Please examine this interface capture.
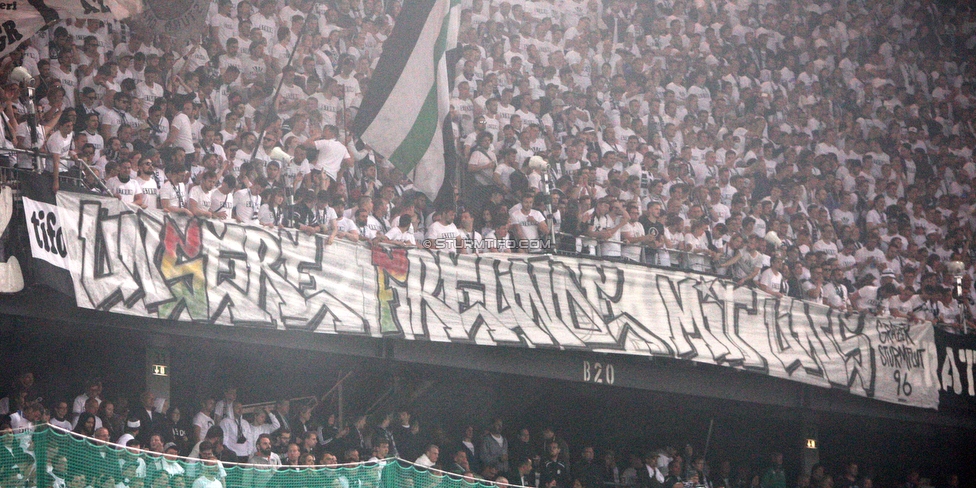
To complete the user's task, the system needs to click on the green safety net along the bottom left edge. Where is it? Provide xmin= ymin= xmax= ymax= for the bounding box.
xmin=0 ymin=426 xmax=504 ymax=488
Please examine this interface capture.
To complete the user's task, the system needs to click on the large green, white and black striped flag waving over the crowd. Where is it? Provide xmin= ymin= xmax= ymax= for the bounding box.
xmin=353 ymin=0 xmax=460 ymax=200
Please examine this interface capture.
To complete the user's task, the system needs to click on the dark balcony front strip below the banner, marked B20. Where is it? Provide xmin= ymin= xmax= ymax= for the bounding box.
xmin=0 ymin=288 xmax=976 ymax=430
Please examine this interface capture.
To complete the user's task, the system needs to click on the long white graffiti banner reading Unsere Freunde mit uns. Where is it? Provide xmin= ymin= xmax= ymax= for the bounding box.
xmin=58 ymin=192 xmax=938 ymax=408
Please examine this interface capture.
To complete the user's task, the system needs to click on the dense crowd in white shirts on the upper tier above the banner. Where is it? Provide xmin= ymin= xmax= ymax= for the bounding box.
xmin=0 ymin=0 xmax=976 ymax=344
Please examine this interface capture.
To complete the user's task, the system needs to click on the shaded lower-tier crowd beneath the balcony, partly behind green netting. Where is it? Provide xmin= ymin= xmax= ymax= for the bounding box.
xmin=0 ymin=372 xmax=960 ymax=488
